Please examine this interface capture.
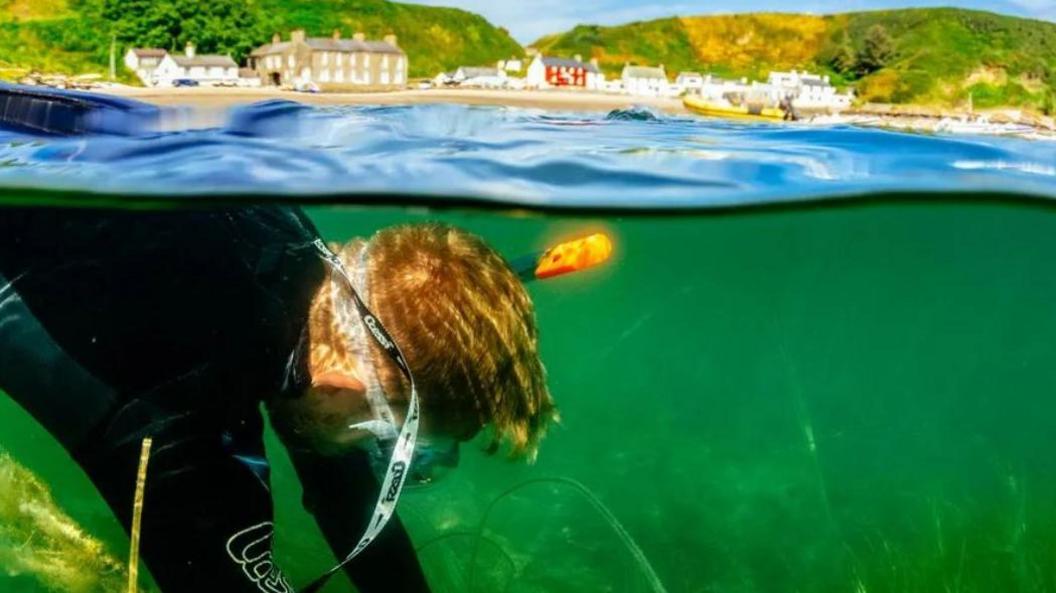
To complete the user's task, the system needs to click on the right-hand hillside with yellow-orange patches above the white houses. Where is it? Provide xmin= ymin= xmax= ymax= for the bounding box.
xmin=532 ymin=8 xmax=1056 ymax=112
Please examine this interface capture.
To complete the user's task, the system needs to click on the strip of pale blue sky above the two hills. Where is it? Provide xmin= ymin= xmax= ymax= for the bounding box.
xmin=401 ymin=0 xmax=1056 ymax=44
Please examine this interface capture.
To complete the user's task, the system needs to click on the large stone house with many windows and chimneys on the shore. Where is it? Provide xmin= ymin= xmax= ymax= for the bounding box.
xmin=249 ymin=30 xmax=408 ymax=89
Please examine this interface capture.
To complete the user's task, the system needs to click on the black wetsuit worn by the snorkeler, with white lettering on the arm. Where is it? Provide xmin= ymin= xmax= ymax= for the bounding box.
xmin=0 ymin=207 xmax=428 ymax=593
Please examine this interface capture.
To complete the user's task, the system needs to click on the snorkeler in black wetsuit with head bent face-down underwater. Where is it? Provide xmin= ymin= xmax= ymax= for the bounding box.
xmin=0 ymin=207 xmax=555 ymax=593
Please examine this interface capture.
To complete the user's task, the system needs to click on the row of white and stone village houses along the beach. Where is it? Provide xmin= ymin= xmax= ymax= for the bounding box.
xmin=113 ymin=30 xmax=854 ymax=113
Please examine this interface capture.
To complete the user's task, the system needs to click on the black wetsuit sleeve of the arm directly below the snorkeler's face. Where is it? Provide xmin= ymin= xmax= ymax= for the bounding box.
xmin=289 ymin=447 xmax=429 ymax=593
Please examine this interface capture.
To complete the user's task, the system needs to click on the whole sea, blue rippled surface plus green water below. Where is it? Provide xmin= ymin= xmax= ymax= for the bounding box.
xmin=0 ymin=103 xmax=1056 ymax=593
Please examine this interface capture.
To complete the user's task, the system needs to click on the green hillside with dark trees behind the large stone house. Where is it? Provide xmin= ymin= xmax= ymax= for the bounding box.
xmin=0 ymin=0 xmax=524 ymax=79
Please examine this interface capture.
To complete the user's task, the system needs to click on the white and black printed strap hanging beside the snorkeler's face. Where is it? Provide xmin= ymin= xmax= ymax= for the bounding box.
xmin=303 ymin=238 xmax=418 ymax=593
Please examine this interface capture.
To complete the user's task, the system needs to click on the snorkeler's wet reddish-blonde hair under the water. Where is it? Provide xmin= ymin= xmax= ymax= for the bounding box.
xmin=312 ymin=224 xmax=557 ymax=458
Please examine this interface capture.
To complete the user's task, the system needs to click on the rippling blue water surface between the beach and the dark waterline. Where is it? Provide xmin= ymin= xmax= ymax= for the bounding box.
xmin=0 ymin=103 xmax=1056 ymax=208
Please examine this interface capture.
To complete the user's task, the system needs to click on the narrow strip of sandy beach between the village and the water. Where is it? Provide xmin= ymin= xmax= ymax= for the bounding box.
xmin=99 ymin=87 xmax=687 ymax=114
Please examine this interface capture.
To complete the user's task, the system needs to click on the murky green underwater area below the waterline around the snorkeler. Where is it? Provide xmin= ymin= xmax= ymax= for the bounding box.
xmin=0 ymin=199 xmax=1056 ymax=593
